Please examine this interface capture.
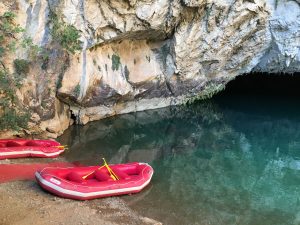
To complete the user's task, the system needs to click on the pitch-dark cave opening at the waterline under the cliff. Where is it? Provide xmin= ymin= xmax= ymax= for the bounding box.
xmin=212 ymin=73 xmax=300 ymax=117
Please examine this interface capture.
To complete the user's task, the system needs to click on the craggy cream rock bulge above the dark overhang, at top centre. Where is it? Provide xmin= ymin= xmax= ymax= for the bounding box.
xmin=61 ymin=0 xmax=181 ymax=47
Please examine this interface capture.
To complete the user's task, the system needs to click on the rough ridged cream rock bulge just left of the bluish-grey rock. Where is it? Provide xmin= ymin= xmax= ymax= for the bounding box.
xmin=174 ymin=1 xmax=269 ymax=80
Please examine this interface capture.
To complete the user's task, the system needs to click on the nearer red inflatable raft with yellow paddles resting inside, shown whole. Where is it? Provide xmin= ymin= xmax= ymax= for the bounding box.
xmin=35 ymin=163 xmax=153 ymax=200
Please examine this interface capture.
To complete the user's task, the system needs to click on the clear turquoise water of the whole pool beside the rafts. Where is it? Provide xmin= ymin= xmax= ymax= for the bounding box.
xmin=60 ymin=93 xmax=300 ymax=225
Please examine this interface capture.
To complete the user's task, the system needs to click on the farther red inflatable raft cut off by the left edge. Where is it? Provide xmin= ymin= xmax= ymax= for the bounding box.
xmin=0 ymin=139 xmax=65 ymax=159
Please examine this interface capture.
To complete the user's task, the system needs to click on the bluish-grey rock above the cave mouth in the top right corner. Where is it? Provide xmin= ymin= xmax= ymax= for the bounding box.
xmin=254 ymin=1 xmax=300 ymax=73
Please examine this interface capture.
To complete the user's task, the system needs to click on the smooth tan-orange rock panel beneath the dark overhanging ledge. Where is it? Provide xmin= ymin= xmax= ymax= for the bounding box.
xmin=59 ymin=40 xmax=163 ymax=107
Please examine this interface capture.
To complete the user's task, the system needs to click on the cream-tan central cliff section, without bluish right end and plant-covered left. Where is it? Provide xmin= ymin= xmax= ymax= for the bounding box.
xmin=52 ymin=0 xmax=271 ymax=123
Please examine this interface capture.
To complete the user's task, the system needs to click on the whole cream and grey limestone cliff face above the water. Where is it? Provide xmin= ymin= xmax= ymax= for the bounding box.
xmin=0 ymin=0 xmax=300 ymax=136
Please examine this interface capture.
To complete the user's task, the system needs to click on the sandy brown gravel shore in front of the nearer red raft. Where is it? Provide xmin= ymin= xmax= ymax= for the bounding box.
xmin=0 ymin=176 xmax=161 ymax=225
